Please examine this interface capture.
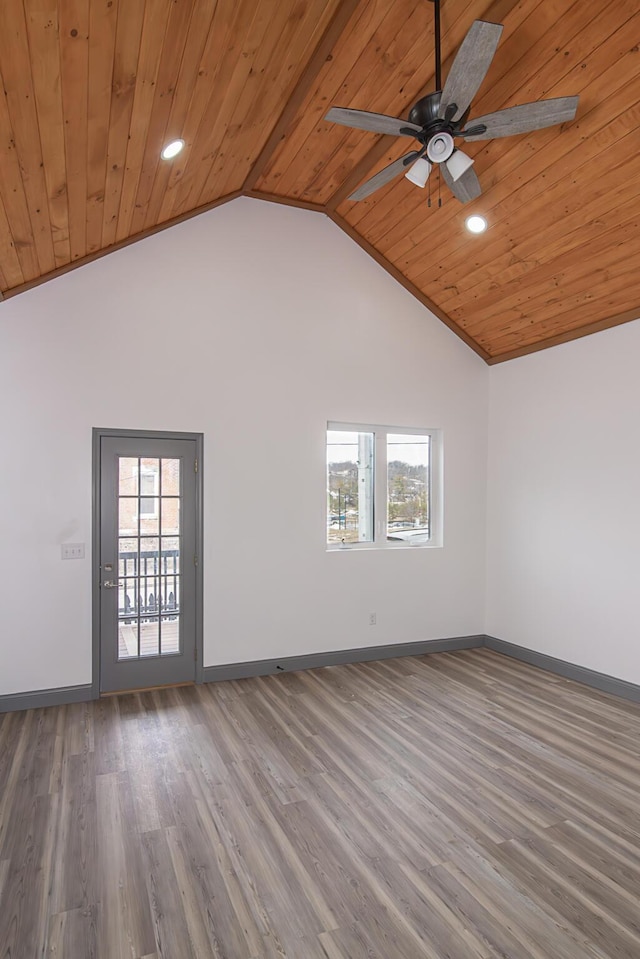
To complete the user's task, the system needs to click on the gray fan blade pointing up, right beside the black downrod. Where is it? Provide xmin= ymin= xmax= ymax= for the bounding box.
xmin=438 ymin=20 xmax=503 ymax=121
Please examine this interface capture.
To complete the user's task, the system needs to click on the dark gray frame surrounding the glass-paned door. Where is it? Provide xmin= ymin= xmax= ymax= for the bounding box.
xmin=91 ymin=426 xmax=204 ymax=699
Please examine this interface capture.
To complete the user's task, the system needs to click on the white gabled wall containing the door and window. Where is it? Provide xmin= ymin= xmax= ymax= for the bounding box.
xmin=0 ymin=199 xmax=489 ymax=694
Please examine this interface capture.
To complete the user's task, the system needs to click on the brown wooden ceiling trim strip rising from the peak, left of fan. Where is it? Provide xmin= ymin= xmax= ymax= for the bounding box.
xmin=242 ymin=0 xmax=360 ymax=194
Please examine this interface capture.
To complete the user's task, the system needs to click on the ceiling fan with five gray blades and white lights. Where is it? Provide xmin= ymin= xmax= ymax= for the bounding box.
xmin=325 ymin=0 xmax=579 ymax=203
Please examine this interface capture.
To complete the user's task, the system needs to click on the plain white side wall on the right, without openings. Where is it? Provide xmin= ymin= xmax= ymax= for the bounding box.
xmin=486 ymin=322 xmax=640 ymax=683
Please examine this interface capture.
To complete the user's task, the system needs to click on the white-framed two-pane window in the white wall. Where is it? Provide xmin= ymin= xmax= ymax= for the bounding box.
xmin=327 ymin=423 xmax=442 ymax=547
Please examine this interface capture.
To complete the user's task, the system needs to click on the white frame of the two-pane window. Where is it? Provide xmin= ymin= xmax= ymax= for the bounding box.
xmin=324 ymin=420 xmax=444 ymax=553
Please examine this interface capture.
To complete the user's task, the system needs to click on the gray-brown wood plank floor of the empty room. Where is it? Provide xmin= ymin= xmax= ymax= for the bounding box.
xmin=0 ymin=649 xmax=640 ymax=959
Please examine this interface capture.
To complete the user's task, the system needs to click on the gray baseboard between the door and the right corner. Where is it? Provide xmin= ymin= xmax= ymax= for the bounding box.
xmin=203 ymin=635 xmax=484 ymax=683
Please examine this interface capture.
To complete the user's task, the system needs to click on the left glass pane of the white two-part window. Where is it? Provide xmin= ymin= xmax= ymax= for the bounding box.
xmin=327 ymin=430 xmax=374 ymax=543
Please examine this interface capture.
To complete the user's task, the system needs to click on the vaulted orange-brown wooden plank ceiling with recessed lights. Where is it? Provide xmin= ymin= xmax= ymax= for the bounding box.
xmin=0 ymin=0 xmax=640 ymax=363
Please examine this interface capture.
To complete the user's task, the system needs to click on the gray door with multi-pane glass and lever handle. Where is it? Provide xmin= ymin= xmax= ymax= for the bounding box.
xmin=99 ymin=434 xmax=197 ymax=692
